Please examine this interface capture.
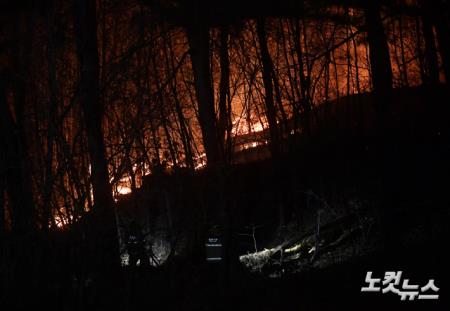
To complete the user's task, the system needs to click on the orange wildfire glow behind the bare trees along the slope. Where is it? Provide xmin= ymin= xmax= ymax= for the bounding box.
xmin=1 ymin=0 xmax=444 ymax=227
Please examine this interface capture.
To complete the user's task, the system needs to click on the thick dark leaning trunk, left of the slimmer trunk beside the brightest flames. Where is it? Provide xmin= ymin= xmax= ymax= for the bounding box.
xmin=187 ymin=16 xmax=222 ymax=165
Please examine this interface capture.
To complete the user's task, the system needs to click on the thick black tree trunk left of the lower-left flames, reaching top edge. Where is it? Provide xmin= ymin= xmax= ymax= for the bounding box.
xmin=73 ymin=0 xmax=119 ymax=271
